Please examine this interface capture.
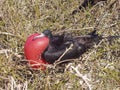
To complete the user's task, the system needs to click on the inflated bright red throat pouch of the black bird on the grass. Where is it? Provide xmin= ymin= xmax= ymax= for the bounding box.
xmin=24 ymin=33 xmax=49 ymax=70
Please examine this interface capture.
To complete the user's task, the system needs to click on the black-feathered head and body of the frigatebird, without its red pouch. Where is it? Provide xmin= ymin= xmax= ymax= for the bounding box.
xmin=36 ymin=30 xmax=102 ymax=64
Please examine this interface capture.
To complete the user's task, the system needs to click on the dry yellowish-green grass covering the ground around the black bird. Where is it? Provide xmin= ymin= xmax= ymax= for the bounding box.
xmin=0 ymin=0 xmax=120 ymax=90
